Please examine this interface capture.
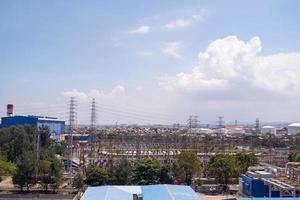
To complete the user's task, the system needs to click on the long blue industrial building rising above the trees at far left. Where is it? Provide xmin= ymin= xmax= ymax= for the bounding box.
xmin=1 ymin=116 xmax=65 ymax=139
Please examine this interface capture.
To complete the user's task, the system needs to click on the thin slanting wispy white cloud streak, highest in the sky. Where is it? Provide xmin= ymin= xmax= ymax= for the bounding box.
xmin=162 ymin=15 xmax=202 ymax=30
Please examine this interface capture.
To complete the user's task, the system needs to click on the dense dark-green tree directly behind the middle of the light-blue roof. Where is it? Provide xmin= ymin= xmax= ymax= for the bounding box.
xmin=131 ymin=159 xmax=160 ymax=185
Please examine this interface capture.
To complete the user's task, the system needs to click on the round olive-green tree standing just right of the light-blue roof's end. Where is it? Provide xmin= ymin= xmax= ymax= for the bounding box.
xmin=206 ymin=154 xmax=240 ymax=186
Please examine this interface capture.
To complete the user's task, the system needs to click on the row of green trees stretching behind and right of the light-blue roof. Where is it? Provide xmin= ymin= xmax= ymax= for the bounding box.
xmin=74 ymin=151 xmax=258 ymax=189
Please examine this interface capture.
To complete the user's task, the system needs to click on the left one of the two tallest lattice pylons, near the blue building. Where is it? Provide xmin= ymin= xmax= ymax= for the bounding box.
xmin=68 ymin=97 xmax=76 ymax=172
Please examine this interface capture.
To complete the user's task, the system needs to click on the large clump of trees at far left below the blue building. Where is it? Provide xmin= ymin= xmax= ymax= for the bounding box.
xmin=0 ymin=126 xmax=65 ymax=191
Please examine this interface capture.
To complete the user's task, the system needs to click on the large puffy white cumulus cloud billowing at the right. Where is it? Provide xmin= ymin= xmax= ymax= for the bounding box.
xmin=159 ymin=36 xmax=300 ymax=97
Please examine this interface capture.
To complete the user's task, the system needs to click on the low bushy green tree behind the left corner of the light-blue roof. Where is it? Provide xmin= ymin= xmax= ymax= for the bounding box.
xmin=85 ymin=165 xmax=108 ymax=186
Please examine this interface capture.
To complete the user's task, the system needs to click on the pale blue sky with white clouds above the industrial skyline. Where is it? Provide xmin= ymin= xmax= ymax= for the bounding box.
xmin=0 ymin=0 xmax=300 ymax=124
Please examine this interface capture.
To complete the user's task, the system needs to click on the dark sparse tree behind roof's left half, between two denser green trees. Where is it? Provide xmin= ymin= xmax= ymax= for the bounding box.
xmin=108 ymin=159 xmax=131 ymax=185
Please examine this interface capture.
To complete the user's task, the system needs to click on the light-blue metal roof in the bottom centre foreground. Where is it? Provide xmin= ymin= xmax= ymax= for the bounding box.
xmin=81 ymin=185 xmax=201 ymax=200
